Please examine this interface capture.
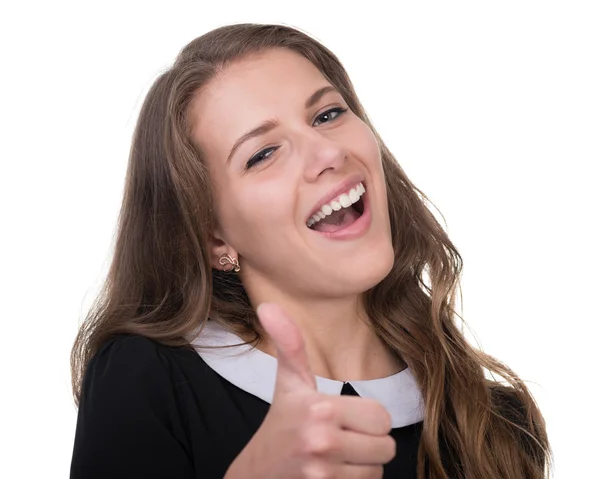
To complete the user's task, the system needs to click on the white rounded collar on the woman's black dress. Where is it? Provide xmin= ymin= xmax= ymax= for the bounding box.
xmin=191 ymin=320 xmax=424 ymax=428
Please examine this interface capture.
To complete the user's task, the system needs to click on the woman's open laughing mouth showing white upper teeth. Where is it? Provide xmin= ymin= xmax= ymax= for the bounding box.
xmin=306 ymin=182 xmax=366 ymax=233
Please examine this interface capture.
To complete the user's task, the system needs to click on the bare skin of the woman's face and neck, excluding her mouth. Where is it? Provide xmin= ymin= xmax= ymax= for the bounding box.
xmin=190 ymin=49 xmax=405 ymax=380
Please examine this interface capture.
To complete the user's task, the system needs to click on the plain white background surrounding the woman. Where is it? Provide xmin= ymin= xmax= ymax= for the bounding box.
xmin=0 ymin=0 xmax=600 ymax=479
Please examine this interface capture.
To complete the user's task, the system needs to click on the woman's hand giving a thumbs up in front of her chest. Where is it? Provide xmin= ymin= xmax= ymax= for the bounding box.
xmin=225 ymin=303 xmax=396 ymax=479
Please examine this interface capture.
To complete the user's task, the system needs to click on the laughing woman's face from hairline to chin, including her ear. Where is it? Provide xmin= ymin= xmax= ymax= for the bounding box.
xmin=190 ymin=49 xmax=394 ymax=301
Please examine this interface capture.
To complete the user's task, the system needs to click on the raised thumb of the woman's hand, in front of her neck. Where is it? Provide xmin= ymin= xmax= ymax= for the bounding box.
xmin=256 ymin=303 xmax=317 ymax=395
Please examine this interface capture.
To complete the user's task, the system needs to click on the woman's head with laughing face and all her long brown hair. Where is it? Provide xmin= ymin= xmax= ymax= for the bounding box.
xmin=72 ymin=24 xmax=547 ymax=478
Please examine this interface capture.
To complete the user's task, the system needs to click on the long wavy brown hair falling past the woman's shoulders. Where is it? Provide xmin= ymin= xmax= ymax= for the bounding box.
xmin=71 ymin=24 xmax=552 ymax=479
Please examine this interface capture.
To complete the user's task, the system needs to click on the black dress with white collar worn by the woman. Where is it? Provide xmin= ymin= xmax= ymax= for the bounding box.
xmin=71 ymin=321 xmax=432 ymax=479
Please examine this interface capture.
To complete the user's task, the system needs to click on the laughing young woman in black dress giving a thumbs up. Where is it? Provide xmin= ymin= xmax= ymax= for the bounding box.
xmin=71 ymin=24 xmax=551 ymax=479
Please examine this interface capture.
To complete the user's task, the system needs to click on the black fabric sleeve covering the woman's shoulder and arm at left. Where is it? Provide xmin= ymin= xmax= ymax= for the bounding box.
xmin=71 ymin=336 xmax=195 ymax=479
